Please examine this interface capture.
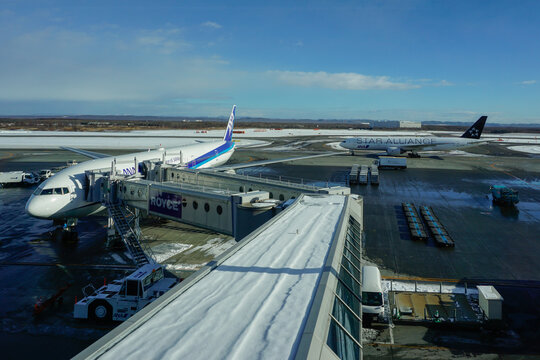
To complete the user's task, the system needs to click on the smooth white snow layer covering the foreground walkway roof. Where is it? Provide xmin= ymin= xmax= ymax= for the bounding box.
xmin=101 ymin=195 xmax=344 ymax=359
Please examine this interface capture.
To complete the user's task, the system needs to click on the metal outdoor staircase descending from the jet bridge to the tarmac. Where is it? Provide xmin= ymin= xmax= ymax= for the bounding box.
xmin=107 ymin=203 xmax=154 ymax=267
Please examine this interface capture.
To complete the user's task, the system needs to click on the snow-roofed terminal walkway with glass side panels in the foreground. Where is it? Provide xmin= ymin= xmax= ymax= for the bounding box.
xmin=76 ymin=193 xmax=363 ymax=359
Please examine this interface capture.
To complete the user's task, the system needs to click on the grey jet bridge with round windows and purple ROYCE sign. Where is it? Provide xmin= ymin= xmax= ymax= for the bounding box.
xmin=105 ymin=164 xmax=350 ymax=240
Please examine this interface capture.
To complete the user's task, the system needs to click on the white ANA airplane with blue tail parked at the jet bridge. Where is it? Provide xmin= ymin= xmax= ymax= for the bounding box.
xmin=26 ymin=105 xmax=236 ymax=220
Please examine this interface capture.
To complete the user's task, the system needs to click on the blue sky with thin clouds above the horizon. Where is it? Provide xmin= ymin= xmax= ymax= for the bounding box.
xmin=0 ymin=0 xmax=540 ymax=124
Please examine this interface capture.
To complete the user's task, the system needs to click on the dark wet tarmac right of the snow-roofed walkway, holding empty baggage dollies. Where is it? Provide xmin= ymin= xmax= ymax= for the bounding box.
xmin=234 ymin=145 xmax=540 ymax=359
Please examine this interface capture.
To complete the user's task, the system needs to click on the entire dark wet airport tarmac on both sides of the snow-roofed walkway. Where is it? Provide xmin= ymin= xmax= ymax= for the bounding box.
xmin=0 ymin=139 xmax=540 ymax=358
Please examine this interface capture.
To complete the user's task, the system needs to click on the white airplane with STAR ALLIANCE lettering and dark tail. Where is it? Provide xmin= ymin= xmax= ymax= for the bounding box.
xmin=340 ymin=116 xmax=487 ymax=155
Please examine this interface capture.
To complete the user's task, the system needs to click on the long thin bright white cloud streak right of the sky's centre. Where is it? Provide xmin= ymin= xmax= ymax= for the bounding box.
xmin=269 ymin=71 xmax=420 ymax=90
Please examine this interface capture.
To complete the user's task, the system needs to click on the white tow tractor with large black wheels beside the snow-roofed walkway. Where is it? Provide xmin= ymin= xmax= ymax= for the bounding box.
xmin=73 ymin=264 xmax=177 ymax=321
